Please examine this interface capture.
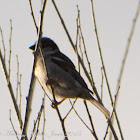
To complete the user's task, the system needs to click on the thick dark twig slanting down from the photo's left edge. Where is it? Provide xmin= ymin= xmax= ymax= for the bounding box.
xmin=0 ymin=27 xmax=23 ymax=129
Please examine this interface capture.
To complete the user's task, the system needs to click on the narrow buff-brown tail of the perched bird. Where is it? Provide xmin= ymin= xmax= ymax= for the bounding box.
xmin=89 ymin=98 xmax=110 ymax=119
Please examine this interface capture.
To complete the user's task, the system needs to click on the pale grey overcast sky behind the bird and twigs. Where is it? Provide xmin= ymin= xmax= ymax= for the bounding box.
xmin=0 ymin=0 xmax=140 ymax=140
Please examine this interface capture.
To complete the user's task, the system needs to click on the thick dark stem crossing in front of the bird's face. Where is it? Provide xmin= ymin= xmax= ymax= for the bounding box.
xmin=21 ymin=0 xmax=47 ymax=140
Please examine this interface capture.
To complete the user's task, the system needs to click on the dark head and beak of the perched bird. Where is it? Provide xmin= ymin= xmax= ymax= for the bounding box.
xmin=29 ymin=37 xmax=59 ymax=52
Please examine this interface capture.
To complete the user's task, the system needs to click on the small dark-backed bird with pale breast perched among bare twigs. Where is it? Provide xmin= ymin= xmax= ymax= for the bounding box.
xmin=29 ymin=37 xmax=110 ymax=119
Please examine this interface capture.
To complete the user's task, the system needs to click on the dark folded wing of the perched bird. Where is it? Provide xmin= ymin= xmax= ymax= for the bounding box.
xmin=51 ymin=51 xmax=88 ymax=89
